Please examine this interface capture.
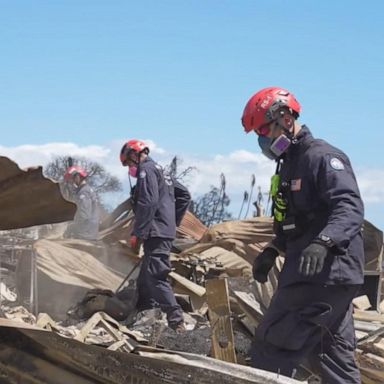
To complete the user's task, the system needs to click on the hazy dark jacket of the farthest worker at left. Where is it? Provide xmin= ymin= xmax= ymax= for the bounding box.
xmin=67 ymin=183 xmax=99 ymax=240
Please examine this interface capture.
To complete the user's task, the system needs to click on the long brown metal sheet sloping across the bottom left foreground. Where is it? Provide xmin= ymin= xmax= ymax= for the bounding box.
xmin=0 ymin=322 xmax=299 ymax=384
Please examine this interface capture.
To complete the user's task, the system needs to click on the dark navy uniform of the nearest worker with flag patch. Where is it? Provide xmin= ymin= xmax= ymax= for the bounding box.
xmin=251 ymin=126 xmax=364 ymax=384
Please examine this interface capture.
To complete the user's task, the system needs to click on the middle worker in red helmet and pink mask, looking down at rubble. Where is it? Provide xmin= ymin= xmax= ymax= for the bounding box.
xmin=120 ymin=139 xmax=190 ymax=332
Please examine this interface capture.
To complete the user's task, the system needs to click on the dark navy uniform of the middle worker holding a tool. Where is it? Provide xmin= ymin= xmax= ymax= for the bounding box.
xmin=132 ymin=157 xmax=184 ymax=327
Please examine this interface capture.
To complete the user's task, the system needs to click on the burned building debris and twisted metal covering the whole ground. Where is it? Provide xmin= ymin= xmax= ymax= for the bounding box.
xmin=0 ymin=158 xmax=384 ymax=384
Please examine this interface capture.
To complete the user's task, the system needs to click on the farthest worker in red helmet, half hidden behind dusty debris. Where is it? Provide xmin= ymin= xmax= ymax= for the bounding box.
xmin=64 ymin=166 xmax=99 ymax=240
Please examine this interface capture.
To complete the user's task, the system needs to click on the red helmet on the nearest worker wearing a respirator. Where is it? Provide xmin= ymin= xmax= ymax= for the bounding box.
xmin=241 ymin=87 xmax=301 ymax=135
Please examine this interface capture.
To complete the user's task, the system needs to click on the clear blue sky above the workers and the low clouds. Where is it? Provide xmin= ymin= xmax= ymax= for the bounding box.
xmin=0 ymin=0 xmax=384 ymax=228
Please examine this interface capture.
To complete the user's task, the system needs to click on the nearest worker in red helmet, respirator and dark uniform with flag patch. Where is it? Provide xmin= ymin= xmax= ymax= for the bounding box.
xmin=242 ymin=87 xmax=364 ymax=384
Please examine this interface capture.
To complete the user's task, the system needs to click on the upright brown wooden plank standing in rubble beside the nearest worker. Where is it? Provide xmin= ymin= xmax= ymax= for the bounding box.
xmin=205 ymin=279 xmax=236 ymax=363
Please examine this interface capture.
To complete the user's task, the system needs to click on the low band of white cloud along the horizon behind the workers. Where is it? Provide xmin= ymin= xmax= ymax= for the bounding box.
xmin=0 ymin=140 xmax=384 ymax=225
